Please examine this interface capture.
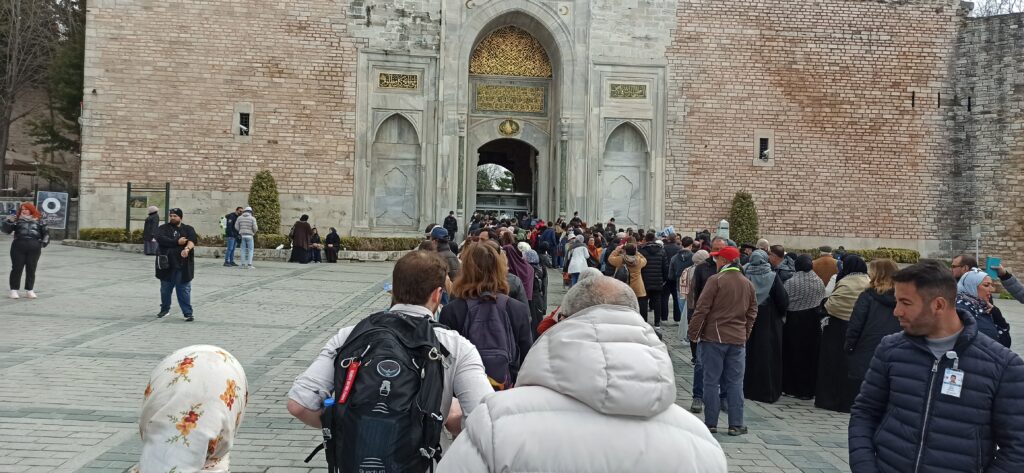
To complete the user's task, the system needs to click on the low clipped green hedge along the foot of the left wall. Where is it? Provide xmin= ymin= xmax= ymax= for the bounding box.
xmin=79 ymin=228 xmax=422 ymax=251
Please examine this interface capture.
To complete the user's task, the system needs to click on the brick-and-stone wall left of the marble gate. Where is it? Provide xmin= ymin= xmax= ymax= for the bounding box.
xmin=82 ymin=0 xmax=357 ymax=233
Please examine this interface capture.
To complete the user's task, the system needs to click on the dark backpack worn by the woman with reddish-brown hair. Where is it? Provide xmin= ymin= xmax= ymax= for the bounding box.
xmin=461 ymin=293 xmax=519 ymax=391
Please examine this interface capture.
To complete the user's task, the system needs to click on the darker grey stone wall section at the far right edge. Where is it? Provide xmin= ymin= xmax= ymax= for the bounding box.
xmin=945 ymin=14 xmax=1024 ymax=271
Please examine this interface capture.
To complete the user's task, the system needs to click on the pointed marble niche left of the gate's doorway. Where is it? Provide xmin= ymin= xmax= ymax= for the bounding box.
xmin=370 ymin=114 xmax=420 ymax=228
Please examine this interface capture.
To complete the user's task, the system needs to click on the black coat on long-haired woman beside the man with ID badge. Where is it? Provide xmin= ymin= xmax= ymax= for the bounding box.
xmin=844 ymin=289 xmax=902 ymax=380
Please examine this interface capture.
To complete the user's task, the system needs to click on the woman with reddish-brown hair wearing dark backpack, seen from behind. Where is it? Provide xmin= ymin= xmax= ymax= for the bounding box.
xmin=439 ymin=244 xmax=534 ymax=391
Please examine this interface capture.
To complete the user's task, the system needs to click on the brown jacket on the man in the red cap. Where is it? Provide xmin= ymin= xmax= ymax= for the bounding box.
xmin=689 ymin=270 xmax=758 ymax=345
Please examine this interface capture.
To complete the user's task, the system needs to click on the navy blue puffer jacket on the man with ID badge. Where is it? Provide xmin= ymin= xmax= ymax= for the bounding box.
xmin=850 ymin=312 xmax=1024 ymax=473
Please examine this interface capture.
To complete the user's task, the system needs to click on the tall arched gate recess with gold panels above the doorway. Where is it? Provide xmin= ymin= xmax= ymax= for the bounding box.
xmin=464 ymin=22 xmax=557 ymax=218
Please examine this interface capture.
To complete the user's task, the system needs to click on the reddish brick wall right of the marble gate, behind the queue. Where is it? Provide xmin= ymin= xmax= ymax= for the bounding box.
xmin=666 ymin=0 xmax=964 ymax=252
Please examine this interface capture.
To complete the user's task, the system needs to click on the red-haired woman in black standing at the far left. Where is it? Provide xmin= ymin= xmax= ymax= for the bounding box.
xmin=0 ymin=202 xmax=50 ymax=299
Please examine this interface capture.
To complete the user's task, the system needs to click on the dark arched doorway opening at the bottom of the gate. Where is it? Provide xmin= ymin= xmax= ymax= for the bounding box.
xmin=476 ymin=138 xmax=539 ymax=217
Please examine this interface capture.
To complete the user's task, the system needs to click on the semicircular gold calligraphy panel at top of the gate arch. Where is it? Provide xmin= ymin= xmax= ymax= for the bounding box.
xmin=469 ymin=27 xmax=551 ymax=78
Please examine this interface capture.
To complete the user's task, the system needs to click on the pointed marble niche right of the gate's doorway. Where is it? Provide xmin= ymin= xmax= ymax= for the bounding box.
xmin=601 ymin=122 xmax=648 ymax=228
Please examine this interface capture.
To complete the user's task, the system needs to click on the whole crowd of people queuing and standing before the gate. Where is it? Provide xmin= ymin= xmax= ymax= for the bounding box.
xmin=9 ymin=204 xmax=1024 ymax=473
